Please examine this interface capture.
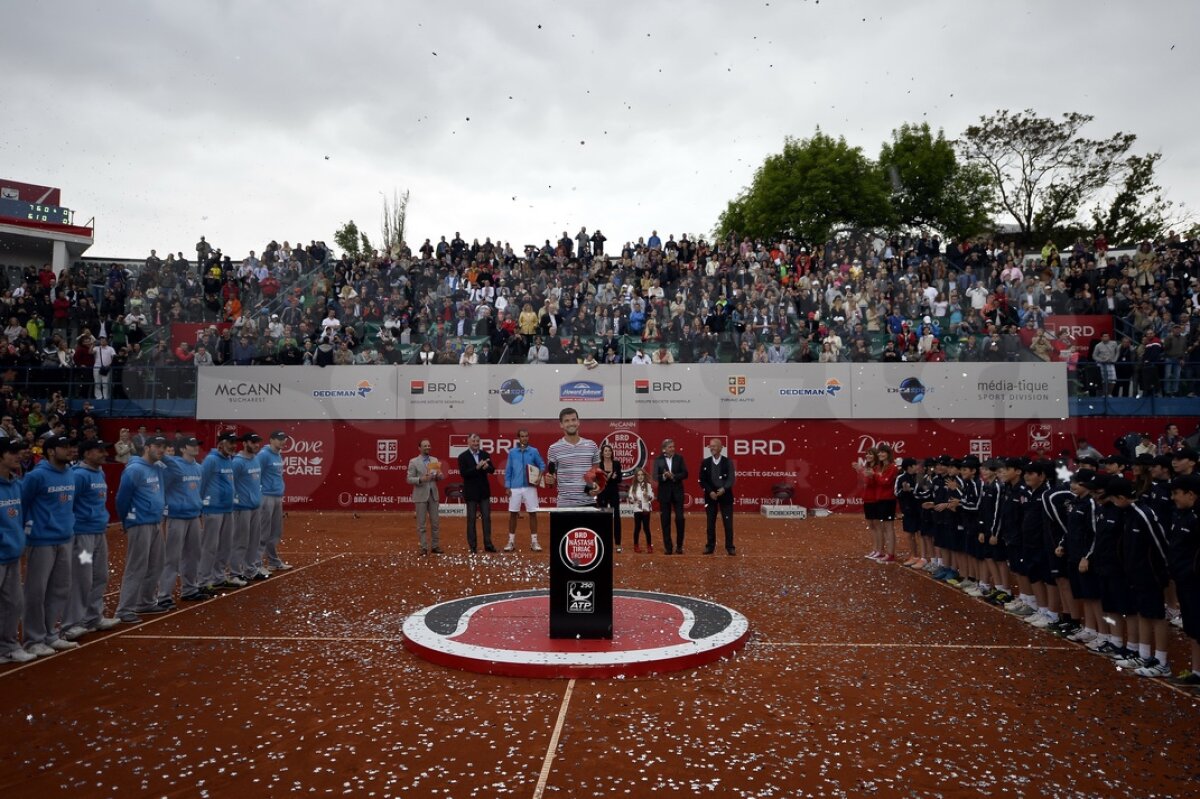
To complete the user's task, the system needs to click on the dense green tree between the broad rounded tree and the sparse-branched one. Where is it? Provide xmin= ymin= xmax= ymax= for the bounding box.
xmin=880 ymin=122 xmax=996 ymax=239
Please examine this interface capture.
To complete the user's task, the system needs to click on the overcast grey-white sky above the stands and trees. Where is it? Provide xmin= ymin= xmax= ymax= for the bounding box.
xmin=0 ymin=0 xmax=1200 ymax=258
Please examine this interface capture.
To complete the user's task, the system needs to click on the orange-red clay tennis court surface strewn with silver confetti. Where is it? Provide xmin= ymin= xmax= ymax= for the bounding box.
xmin=0 ymin=513 xmax=1200 ymax=798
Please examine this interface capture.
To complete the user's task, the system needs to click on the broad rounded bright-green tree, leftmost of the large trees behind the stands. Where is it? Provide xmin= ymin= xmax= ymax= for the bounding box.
xmin=716 ymin=128 xmax=890 ymax=242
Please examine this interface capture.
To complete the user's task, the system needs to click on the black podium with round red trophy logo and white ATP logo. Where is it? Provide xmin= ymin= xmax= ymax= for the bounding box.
xmin=548 ymin=507 xmax=612 ymax=638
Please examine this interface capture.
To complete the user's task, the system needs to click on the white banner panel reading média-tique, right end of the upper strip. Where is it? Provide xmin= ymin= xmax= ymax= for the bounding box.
xmin=851 ymin=362 xmax=1069 ymax=420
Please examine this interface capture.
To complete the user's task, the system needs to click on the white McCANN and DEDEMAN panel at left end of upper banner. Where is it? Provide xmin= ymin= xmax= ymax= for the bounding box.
xmin=196 ymin=366 xmax=397 ymax=420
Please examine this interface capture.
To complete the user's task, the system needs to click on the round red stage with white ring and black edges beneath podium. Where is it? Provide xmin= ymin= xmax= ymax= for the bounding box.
xmin=403 ymin=589 xmax=750 ymax=678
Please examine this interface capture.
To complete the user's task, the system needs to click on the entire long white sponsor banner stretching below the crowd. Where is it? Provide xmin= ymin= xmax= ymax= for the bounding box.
xmin=197 ymin=364 xmax=1068 ymax=420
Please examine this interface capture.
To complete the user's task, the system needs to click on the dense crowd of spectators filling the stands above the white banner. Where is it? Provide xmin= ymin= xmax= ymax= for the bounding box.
xmin=0 ymin=221 xmax=1200 ymax=398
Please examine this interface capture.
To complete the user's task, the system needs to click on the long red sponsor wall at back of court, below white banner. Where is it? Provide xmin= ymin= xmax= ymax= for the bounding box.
xmin=101 ymin=409 xmax=1196 ymax=513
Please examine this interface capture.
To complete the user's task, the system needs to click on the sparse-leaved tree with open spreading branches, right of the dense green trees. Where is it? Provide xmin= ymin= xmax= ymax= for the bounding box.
xmin=958 ymin=109 xmax=1138 ymax=244
